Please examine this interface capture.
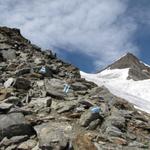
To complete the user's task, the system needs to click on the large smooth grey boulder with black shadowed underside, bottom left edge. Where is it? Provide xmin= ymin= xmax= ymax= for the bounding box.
xmin=0 ymin=113 xmax=35 ymax=139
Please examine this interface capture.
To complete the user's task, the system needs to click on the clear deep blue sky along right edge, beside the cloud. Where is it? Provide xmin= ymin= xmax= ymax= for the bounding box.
xmin=129 ymin=0 xmax=150 ymax=68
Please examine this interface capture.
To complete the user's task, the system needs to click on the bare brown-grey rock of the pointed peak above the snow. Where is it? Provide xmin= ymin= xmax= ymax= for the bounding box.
xmin=102 ymin=53 xmax=150 ymax=81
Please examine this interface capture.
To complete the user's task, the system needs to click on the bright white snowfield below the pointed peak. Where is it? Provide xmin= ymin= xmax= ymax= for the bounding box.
xmin=80 ymin=68 xmax=150 ymax=113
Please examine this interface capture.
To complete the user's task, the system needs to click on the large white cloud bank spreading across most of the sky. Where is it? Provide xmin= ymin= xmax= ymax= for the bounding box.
xmin=0 ymin=0 xmax=138 ymax=70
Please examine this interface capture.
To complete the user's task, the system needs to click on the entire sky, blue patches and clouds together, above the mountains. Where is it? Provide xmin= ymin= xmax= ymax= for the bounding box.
xmin=0 ymin=0 xmax=150 ymax=72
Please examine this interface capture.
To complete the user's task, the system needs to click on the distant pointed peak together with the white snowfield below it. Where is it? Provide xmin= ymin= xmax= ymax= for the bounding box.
xmin=80 ymin=53 xmax=150 ymax=113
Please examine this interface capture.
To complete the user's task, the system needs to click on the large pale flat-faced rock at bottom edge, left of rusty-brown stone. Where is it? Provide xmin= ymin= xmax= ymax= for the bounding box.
xmin=35 ymin=122 xmax=72 ymax=150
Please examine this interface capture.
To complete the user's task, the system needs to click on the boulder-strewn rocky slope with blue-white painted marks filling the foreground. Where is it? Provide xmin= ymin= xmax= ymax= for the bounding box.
xmin=0 ymin=27 xmax=150 ymax=150
